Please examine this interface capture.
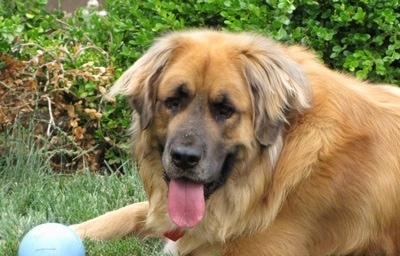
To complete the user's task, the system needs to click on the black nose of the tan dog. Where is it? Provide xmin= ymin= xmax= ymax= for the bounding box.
xmin=171 ymin=146 xmax=201 ymax=170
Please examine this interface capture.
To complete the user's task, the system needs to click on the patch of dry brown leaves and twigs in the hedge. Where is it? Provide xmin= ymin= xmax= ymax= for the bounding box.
xmin=0 ymin=44 xmax=114 ymax=171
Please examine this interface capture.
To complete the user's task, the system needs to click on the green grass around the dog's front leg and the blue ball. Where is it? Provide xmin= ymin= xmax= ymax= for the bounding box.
xmin=0 ymin=121 xmax=162 ymax=256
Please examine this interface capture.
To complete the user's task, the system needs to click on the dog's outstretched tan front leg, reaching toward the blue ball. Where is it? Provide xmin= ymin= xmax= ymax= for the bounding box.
xmin=70 ymin=201 xmax=152 ymax=240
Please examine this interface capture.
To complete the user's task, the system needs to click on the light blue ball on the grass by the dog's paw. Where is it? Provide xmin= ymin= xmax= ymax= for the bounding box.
xmin=18 ymin=223 xmax=85 ymax=256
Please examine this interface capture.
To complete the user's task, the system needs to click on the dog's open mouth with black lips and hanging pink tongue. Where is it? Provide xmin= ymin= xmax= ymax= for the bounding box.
xmin=164 ymin=154 xmax=235 ymax=228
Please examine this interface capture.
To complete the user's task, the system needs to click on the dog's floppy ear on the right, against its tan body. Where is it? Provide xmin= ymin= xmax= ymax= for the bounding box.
xmin=240 ymin=34 xmax=311 ymax=146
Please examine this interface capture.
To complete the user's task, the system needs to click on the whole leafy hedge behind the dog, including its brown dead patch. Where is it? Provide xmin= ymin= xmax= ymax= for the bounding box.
xmin=0 ymin=0 xmax=400 ymax=170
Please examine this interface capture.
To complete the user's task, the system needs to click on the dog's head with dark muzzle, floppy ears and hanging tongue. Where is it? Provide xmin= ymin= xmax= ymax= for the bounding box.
xmin=111 ymin=30 xmax=311 ymax=227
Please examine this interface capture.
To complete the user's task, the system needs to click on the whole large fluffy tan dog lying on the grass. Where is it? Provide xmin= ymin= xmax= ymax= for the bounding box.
xmin=71 ymin=29 xmax=400 ymax=256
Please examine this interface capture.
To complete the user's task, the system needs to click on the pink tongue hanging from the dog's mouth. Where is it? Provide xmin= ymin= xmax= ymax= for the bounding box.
xmin=168 ymin=179 xmax=205 ymax=228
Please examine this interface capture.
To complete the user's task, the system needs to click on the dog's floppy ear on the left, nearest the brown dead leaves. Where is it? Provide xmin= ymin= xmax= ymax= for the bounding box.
xmin=108 ymin=36 xmax=178 ymax=130
